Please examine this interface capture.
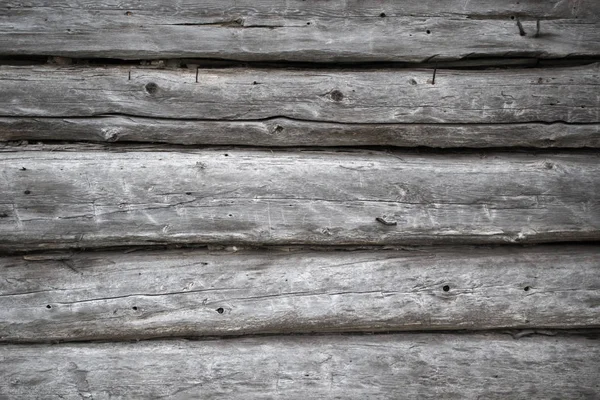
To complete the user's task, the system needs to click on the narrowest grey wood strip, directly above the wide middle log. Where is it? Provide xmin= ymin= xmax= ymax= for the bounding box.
xmin=0 ymin=116 xmax=600 ymax=148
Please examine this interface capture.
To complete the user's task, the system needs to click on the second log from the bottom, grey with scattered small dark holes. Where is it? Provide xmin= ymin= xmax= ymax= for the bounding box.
xmin=0 ymin=245 xmax=600 ymax=342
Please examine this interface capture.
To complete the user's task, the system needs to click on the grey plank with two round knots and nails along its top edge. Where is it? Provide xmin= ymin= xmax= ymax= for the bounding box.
xmin=0 ymin=63 xmax=600 ymax=124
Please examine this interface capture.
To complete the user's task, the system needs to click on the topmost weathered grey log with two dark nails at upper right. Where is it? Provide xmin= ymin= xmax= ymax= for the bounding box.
xmin=0 ymin=0 xmax=600 ymax=62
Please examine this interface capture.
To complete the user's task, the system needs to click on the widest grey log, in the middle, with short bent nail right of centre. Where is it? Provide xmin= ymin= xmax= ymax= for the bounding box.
xmin=0 ymin=146 xmax=600 ymax=250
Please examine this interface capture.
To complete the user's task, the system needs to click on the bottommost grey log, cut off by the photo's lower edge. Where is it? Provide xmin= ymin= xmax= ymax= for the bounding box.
xmin=0 ymin=334 xmax=600 ymax=400
